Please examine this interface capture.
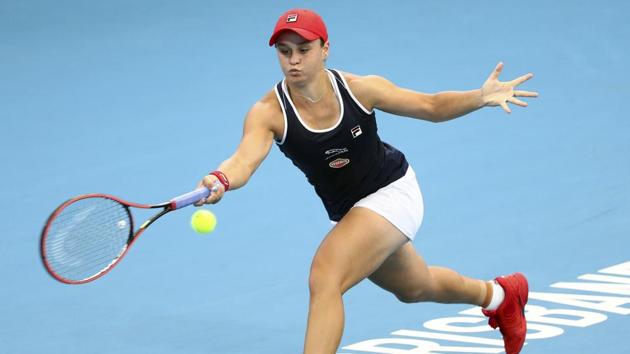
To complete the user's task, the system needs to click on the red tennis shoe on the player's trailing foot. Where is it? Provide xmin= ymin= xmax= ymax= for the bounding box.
xmin=482 ymin=273 xmax=529 ymax=354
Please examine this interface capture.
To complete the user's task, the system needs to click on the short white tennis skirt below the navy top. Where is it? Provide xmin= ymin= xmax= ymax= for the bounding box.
xmin=333 ymin=166 xmax=424 ymax=241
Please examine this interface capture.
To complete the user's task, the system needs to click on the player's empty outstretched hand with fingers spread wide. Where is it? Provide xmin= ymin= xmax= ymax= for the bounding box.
xmin=481 ymin=63 xmax=538 ymax=113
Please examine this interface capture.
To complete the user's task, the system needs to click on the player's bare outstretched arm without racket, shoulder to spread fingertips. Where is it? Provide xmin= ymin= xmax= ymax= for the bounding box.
xmin=348 ymin=63 xmax=538 ymax=122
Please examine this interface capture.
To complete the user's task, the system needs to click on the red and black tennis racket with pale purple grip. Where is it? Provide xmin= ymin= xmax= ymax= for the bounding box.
xmin=40 ymin=186 xmax=217 ymax=284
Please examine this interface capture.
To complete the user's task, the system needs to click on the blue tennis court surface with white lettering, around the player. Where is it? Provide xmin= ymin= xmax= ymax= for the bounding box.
xmin=0 ymin=0 xmax=630 ymax=354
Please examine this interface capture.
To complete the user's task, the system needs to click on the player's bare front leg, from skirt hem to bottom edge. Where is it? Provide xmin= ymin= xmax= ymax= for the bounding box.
xmin=304 ymin=207 xmax=408 ymax=354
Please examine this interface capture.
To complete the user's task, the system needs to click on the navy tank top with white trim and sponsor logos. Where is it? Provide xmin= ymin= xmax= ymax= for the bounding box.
xmin=275 ymin=70 xmax=409 ymax=221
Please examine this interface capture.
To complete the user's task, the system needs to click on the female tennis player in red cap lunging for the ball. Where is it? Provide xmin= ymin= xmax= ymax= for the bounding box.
xmin=197 ymin=9 xmax=537 ymax=354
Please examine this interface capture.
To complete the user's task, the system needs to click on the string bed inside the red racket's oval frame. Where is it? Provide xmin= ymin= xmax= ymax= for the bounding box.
xmin=44 ymin=197 xmax=132 ymax=281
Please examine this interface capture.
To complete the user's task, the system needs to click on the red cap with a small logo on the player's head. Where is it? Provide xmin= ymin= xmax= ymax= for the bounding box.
xmin=269 ymin=9 xmax=328 ymax=46
